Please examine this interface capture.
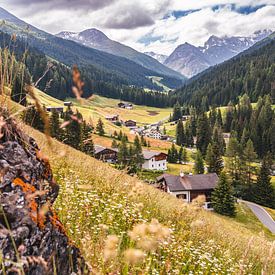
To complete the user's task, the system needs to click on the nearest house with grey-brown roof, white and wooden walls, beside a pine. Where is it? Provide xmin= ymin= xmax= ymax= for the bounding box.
xmin=157 ymin=173 xmax=219 ymax=203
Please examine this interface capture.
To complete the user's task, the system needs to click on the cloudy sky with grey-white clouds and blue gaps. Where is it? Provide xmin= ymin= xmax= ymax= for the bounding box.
xmin=0 ymin=0 xmax=275 ymax=54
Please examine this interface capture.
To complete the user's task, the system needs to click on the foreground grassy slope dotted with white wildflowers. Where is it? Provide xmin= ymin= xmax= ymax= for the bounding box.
xmin=20 ymin=126 xmax=275 ymax=274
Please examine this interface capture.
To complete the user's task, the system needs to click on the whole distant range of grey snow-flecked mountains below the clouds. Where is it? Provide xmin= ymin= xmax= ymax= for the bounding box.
xmin=56 ymin=24 xmax=272 ymax=78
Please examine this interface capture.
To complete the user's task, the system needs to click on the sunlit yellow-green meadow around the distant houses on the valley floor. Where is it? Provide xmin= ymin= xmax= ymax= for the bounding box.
xmin=32 ymin=89 xmax=175 ymax=151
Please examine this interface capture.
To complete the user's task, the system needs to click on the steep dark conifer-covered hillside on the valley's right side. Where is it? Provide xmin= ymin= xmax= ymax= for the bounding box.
xmin=173 ymin=33 xmax=275 ymax=106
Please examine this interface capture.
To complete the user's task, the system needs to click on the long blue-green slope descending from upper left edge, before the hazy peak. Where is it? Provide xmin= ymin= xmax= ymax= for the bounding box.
xmin=0 ymin=6 xmax=182 ymax=89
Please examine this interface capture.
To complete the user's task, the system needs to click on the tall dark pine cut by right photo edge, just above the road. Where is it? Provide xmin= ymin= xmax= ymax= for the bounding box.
xmin=252 ymin=155 xmax=275 ymax=208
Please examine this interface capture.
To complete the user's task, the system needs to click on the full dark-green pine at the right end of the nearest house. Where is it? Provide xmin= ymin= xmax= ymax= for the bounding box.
xmin=211 ymin=173 xmax=236 ymax=217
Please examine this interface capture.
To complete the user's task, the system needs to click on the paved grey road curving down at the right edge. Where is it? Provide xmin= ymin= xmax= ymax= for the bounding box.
xmin=240 ymin=200 xmax=275 ymax=234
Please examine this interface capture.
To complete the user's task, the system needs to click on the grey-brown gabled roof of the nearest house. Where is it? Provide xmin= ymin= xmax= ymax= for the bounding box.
xmin=157 ymin=173 xmax=219 ymax=192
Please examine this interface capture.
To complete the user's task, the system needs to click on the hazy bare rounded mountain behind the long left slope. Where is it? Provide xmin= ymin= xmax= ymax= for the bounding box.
xmin=56 ymin=28 xmax=183 ymax=79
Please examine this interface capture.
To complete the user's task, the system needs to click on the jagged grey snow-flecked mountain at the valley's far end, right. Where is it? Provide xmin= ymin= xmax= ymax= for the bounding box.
xmin=164 ymin=30 xmax=271 ymax=77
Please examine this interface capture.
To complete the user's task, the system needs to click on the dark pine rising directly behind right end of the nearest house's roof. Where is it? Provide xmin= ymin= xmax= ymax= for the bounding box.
xmin=205 ymin=143 xmax=223 ymax=175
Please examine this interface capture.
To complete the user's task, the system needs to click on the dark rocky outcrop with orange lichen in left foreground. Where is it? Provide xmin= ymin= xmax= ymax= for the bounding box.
xmin=0 ymin=110 xmax=88 ymax=274
